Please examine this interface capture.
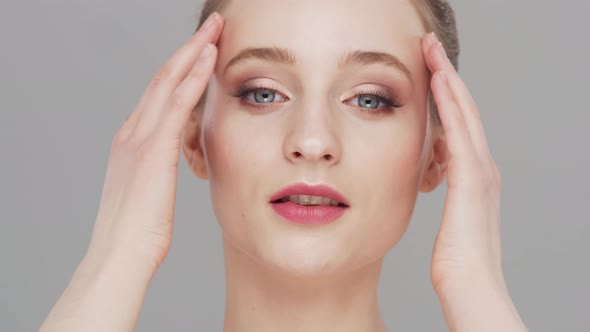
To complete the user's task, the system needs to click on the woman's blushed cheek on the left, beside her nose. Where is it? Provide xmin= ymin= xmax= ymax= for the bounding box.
xmin=203 ymin=101 xmax=277 ymax=247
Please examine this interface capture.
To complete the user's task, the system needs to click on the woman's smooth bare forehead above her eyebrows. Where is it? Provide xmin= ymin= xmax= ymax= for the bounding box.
xmin=219 ymin=0 xmax=424 ymax=72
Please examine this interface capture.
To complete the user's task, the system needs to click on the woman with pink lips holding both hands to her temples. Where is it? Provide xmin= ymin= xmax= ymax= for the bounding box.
xmin=41 ymin=0 xmax=526 ymax=332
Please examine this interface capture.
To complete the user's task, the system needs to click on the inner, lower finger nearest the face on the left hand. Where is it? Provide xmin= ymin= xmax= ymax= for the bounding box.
xmin=158 ymin=44 xmax=217 ymax=137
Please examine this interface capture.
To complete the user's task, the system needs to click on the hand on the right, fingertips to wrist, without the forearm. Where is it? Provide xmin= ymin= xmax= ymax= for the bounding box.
xmin=422 ymin=34 xmax=504 ymax=295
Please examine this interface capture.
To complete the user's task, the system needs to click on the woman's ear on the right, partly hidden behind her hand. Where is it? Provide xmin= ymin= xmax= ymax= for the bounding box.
xmin=420 ymin=130 xmax=450 ymax=193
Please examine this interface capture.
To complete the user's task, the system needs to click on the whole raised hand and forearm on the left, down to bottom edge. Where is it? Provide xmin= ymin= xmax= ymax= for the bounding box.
xmin=41 ymin=13 xmax=224 ymax=332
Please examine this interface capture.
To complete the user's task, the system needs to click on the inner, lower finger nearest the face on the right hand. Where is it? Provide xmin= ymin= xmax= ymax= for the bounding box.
xmin=431 ymin=71 xmax=474 ymax=162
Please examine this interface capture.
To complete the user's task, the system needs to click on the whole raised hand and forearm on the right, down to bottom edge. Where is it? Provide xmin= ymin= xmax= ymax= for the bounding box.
xmin=422 ymin=33 xmax=527 ymax=331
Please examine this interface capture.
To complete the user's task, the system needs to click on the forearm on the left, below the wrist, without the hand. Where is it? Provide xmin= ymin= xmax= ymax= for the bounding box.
xmin=40 ymin=249 xmax=153 ymax=332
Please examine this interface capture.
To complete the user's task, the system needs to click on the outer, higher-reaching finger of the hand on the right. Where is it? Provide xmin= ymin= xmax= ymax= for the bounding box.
xmin=424 ymin=34 xmax=489 ymax=155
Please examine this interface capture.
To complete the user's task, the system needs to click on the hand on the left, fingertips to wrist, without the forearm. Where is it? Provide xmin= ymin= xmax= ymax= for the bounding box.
xmin=89 ymin=9 xmax=223 ymax=269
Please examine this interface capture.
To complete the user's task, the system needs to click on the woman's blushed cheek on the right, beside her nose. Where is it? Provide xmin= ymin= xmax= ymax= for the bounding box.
xmin=344 ymin=117 xmax=426 ymax=259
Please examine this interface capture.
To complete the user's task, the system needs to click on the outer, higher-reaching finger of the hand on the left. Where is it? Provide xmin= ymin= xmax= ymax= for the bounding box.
xmin=136 ymin=13 xmax=223 ymax=136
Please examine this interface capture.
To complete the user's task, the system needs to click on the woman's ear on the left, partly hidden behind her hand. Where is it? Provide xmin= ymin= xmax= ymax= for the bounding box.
xmin=182 ymin=110 xmax=208 ymax=180
